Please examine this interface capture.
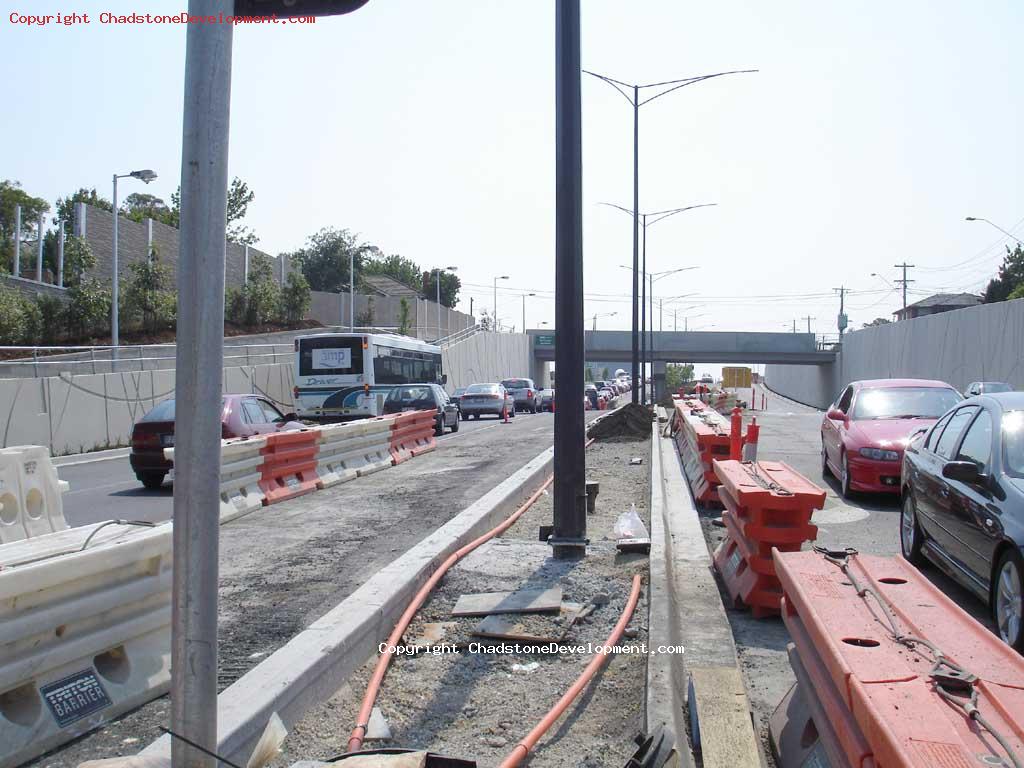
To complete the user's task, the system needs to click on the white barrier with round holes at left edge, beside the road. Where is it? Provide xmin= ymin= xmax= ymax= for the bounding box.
xmin=0 ymin=445 xmax=68 ymax=544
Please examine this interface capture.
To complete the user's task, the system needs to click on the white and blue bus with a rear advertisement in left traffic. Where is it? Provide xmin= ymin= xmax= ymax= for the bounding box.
xmin=292 ymin=333 xmax=447 ymax=424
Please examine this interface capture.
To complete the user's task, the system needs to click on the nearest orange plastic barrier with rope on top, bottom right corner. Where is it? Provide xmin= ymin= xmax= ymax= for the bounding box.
xmin=774 ymin=552 xmax=1024 ymax=768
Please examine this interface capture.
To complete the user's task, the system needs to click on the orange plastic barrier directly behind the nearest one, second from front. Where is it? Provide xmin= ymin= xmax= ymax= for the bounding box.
xmin=714 ymin=461 xmax=825 ymax=618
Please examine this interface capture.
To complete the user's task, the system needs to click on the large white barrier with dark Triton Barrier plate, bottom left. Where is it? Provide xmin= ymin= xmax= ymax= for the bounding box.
xmin=0 ymin=523 xmax=171 ymax=768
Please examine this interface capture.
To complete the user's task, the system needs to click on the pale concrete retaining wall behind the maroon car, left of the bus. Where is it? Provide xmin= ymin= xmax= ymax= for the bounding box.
xmin=0 ymin=360 xmax=294 ymax=456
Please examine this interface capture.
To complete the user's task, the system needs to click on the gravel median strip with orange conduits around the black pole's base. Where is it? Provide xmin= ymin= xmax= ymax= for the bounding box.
xmin=274 ymin=439 xmax=650 ymax=768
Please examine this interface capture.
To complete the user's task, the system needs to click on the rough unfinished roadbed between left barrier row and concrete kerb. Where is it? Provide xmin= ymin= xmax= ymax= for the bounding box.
xmin=27 ymin=414 xmax=597 ymax=768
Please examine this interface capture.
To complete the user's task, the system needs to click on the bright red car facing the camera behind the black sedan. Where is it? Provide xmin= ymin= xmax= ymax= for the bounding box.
xmin=821 ymin=379 xmax=963 ymax=497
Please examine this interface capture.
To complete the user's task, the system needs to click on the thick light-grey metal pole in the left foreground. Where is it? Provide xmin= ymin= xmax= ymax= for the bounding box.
xmin=171 ymin=0 xmax=233 ymax=768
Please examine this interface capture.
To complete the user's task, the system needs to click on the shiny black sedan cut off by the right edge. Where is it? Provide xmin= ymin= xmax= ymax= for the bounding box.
xmin=900 ymin=392 xmax=1024 ymax=651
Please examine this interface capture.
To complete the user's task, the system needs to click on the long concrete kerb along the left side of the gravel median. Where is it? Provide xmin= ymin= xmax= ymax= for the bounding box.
xmin=140 ymin=449 xmax=554 ymax=762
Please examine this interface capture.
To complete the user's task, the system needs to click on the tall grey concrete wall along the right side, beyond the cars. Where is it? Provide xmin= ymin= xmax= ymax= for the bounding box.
xmin=765 ymin=299 xmax=1024 ymax=408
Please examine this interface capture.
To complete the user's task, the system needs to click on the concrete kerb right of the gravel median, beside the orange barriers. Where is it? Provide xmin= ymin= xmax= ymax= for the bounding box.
xmin=645 ymin=427 xmax=762 ymax=768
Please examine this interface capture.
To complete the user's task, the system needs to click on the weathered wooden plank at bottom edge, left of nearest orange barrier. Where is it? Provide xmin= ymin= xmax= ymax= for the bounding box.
xmin=687 ymin=667 xmax=762 ymax=768
